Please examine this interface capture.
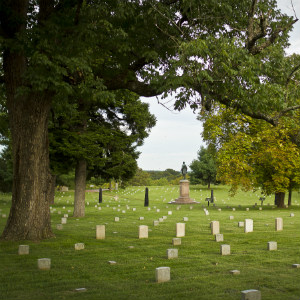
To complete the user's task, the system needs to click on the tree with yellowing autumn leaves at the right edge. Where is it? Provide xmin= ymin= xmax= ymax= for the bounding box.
xmin=199 ymin=107 xmax=300 ymax=207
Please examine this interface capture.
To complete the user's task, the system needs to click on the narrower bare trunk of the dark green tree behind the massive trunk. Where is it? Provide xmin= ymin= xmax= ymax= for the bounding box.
xmin=73 ymin=159 xmax=87 ymax=218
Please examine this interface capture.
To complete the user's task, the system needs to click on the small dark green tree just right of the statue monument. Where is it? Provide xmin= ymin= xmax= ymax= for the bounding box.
xmin=190 ymin=146 xmax=217 ymax=188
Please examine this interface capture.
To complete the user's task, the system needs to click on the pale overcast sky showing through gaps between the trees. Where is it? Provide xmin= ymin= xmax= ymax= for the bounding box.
xmin=138 ymin=0 xmax=300 ymax=171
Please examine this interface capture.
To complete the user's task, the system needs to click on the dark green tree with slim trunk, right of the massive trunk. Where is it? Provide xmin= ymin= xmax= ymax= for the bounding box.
xmin=50 ymin=91 xmax=155 ymax=217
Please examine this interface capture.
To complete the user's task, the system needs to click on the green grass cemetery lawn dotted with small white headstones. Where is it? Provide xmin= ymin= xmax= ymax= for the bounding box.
xmin=0 ymin=186 xmax=300 ymax=300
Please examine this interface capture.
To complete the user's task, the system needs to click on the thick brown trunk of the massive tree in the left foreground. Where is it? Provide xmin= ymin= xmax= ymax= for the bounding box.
xmin=2 ymin=45 xmax=53 ymax=240
